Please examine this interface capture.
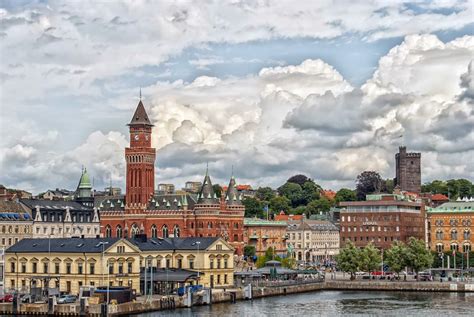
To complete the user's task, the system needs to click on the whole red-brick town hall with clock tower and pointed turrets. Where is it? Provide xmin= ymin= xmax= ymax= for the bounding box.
xmin=96 ymin=101 xmax=245 ymax=254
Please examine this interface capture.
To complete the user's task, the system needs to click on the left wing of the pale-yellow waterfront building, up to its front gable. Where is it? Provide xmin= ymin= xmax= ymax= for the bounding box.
xmin=5 ymin=238 xmax=140 ymax=294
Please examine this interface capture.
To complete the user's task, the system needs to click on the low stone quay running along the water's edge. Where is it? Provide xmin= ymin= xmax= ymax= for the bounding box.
xmin=0 ymin=280 xmax=474 ymax=316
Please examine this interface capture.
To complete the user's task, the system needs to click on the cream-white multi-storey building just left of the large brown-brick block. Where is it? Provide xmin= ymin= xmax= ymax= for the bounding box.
xmin=287 ymin=218 xmax=339 ymax=265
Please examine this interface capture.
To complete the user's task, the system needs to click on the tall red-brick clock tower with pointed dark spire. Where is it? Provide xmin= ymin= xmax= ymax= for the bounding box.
xmin=125 ymin=100 xmax=156 ymax=210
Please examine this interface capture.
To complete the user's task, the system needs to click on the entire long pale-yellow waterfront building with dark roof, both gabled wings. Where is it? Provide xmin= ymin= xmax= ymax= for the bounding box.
xmin=5 ymin=235 xmax=234 ymax=294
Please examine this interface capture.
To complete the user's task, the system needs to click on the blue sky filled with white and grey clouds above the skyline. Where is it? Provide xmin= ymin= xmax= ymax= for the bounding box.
xmin=0 ymin=0 xmax=474 ymax=193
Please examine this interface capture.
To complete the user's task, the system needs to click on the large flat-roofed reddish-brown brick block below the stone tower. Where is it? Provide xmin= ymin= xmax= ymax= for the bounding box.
xmin=340 ymin=194 xmax=425 ymax=249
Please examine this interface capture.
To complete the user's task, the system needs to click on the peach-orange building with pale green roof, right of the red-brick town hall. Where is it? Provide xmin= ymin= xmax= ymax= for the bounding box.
xmin=244 ymin=218 xmax=287 ymax=256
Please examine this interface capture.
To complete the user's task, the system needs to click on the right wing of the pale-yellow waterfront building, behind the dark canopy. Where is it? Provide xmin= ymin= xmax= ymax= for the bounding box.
xmin=130 ymin=235 xmax=234 ymax=292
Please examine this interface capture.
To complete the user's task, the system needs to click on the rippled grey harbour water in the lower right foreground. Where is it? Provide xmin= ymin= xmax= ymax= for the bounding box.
xmin=139 ymin=291 xmax=474 ymax=317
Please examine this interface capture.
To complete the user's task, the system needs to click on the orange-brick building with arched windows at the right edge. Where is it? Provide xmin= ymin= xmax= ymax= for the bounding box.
xmin=426 ymin=201 xmax=474 ymax=253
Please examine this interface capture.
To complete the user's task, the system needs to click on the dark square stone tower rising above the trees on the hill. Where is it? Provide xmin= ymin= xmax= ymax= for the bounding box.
xmin=394 ymin=146 xmax=421 ymax=193
